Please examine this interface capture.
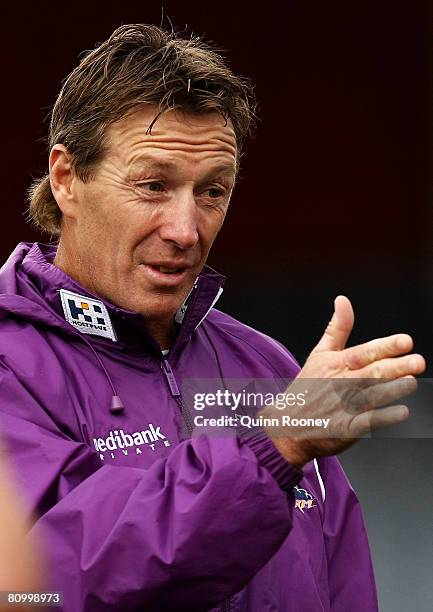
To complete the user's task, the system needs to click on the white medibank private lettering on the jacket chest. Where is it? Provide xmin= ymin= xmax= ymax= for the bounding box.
xmin=93 ymin=423 xmax=170 ymax=461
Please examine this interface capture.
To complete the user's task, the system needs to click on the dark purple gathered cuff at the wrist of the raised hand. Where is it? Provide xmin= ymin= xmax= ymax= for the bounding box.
xmin=239 ymin=429 xmax=304 ymax=490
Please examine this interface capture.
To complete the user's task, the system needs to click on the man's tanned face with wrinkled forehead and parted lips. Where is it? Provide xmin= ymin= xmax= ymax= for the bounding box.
xmin=64 ymin=107 xmax=236 ymax=330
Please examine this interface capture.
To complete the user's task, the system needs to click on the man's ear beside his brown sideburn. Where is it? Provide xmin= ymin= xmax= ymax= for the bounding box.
xmin=49 ymin=144 xmax=76 ymax=217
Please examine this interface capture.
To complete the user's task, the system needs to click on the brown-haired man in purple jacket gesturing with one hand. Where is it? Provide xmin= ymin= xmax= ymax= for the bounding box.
xmin=0 ymin=25 xmax=424 ymax=612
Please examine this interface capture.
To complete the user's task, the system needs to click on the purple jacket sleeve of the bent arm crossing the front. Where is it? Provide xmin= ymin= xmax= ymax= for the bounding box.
xmin=0 ymin=365 xmax=302 ymax=612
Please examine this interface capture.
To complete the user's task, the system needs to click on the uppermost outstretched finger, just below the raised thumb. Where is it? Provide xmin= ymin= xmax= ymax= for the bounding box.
xmin=344 ymin=334 xmax=413 ymax=370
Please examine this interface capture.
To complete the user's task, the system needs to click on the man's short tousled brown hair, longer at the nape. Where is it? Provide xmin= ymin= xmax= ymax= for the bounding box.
xmin=28 ymin=24 xmax=255 ymax=236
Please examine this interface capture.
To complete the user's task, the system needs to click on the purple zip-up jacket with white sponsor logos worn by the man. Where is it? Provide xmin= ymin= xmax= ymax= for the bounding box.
xmin=0 ymin=243 xmax=377 ymax=612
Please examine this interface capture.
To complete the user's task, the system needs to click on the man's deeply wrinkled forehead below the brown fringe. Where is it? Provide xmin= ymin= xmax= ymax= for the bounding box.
xmin=107 ymin=106 xmax=237 ymax=170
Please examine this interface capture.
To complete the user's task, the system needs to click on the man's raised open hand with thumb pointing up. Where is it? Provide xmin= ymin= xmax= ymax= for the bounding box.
xmin=261 ymin=296 xmax=425 ymax=467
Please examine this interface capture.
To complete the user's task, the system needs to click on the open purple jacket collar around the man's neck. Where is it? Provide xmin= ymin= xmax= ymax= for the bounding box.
xmin=13 ymin=242 xmax=225 ymax=356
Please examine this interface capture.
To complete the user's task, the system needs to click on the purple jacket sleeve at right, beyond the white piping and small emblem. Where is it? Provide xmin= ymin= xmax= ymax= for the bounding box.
xmin=318 ymin=457 xmax=378 ymax=612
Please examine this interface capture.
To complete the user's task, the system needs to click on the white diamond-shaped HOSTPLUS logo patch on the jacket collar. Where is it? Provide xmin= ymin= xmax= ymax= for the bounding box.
xmin=60 ymin=289 xmax=117 ymax=342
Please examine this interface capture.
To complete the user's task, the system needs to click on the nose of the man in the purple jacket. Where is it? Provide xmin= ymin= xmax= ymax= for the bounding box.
xmin=160 ymin=191 xmax=199 ymax=249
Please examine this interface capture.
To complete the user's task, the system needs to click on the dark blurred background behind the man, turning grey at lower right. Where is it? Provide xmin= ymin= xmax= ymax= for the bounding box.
xmin=0 ymin=0 xmax=433 ymax=612
